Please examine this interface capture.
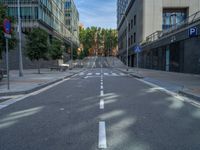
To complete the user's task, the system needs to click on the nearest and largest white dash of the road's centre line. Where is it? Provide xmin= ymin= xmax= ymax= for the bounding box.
xmin=99 ymin=121 xmax=107 ymax=149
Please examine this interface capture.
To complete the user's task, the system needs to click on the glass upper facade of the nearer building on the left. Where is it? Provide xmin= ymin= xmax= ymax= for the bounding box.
xmin=0 ymin=0 xmax=75 ymax=43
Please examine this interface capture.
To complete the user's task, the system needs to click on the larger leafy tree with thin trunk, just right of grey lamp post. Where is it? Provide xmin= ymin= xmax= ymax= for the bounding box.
xmin=26 ymin=28 xmax=49 ymax=74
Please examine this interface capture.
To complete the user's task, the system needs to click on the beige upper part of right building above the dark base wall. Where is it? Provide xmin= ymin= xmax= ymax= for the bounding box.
xmin=118 ymin=0 xmax=200 ymax=57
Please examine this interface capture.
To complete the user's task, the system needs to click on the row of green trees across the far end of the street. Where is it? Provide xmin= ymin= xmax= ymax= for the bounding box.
xmin=80 ymin=27 xmax=117 ymax=56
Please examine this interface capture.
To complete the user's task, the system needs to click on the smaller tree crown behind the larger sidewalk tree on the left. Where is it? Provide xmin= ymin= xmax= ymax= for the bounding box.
xmin=49 ymin=38 xmax=64 ymax=65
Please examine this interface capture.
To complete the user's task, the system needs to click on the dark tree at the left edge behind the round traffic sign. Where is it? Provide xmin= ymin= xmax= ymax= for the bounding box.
xmin=0 ymin=3 xmax=17 ymax=59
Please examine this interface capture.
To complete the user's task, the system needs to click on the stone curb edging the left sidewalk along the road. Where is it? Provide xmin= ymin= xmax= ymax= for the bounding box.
xmin=0 ymin=71 xmax=81 ymax=96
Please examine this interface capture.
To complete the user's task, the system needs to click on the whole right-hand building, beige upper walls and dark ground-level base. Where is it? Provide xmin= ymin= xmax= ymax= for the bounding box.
xmin=118 ymin=0 xmax=200 ymax=73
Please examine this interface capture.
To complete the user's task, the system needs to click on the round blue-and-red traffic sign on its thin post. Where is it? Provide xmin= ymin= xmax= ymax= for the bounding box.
xmin=3 ymin=19 xmax=11 ymax=90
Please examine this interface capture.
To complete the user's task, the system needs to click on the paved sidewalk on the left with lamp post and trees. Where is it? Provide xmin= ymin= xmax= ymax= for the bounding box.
xmin=0 ymin=69 xmax=83 ymax=96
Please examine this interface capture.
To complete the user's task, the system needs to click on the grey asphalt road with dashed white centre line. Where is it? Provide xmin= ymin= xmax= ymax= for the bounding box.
xmin=0 ymin=58 xmax=200 ymax=150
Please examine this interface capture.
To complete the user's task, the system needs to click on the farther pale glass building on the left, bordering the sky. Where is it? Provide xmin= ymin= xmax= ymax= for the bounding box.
xmin=65 ymin=0 xmax=79 ymax=42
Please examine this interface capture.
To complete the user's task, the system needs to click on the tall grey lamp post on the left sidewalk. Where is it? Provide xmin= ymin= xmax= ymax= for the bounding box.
xmin=17 ymin=0 xmax=23 ymax=77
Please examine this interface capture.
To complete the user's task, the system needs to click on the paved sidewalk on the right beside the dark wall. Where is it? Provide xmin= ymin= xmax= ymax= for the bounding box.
xmin=119 ymin=68 xmax=200 ymax=101
